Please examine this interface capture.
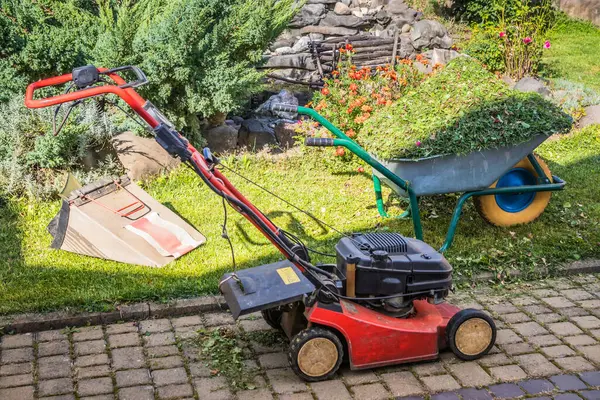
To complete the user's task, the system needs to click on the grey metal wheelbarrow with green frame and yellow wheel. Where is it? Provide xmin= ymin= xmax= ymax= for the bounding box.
xmin=279 ymin=105 xmax=566 ymax=252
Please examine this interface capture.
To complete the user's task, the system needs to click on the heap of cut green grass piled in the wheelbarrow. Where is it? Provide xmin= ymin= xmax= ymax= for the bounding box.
xmin=359 ymin=57 xmax=572 ymax=159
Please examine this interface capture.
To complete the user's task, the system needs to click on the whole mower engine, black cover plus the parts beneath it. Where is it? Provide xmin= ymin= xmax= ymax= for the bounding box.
xmin=335 ymin=233 xmax=452 ymax=317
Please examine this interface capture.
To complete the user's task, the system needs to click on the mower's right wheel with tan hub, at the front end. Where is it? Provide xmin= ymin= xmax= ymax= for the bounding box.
xmin=446 ymin=308 xmax=496 ymax=361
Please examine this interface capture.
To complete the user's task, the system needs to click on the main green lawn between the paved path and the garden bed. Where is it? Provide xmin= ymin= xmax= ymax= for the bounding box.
xmin=0 ymin=128 xmax=600 ymax=313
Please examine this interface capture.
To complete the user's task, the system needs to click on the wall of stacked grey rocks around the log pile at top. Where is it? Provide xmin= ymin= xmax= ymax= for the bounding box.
xmin=265 ymin=0 xmax=452 ymax=82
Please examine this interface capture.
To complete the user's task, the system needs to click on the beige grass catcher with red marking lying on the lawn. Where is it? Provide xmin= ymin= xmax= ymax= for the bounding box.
xmin=48 ymin=176 xmax=206 ymax=267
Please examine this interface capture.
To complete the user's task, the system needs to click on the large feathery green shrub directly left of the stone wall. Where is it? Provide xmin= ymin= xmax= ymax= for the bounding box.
xmin=94 ymin=0 xmax=295 ymax=133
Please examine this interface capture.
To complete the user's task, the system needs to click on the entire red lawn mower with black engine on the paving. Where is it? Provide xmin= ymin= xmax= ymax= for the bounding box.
xmin=25 ymin=65 xmax=496 ymax=381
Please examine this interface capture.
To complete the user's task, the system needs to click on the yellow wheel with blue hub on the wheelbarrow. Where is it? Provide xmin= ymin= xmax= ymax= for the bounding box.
xmin=473 ymin=156 xmax=552 ymax=226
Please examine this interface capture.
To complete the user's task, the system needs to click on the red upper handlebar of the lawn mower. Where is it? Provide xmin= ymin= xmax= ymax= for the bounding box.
xmin=25 ymin=68 xmax=159 ymax=128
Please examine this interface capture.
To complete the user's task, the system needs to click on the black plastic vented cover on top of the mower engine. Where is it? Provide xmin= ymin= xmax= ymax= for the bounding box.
xmin=335 ymin=233 xmax=452 ymax=298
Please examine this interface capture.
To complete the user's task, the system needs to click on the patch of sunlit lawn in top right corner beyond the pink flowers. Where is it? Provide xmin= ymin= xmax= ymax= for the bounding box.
xmin=541 ymin=17 xmax=600 ymax=91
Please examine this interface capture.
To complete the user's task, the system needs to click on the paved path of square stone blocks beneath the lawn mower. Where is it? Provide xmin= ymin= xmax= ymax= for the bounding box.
xmin=0 ymin=275 xmax=600 ymax=400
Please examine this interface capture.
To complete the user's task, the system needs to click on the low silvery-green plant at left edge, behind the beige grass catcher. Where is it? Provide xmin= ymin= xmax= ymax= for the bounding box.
xmin=0 ymin=96 xmax=121 ymax=197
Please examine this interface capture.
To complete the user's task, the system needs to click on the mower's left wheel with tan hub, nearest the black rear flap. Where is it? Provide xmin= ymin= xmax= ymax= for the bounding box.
xmin=288 ymin=327 xmax=344 ymax=382
